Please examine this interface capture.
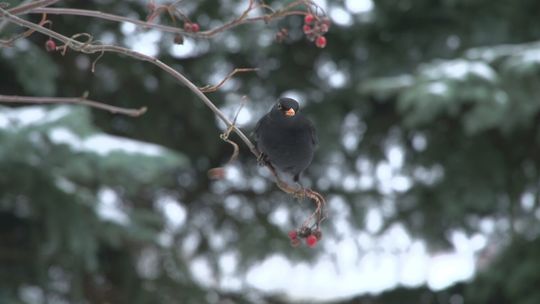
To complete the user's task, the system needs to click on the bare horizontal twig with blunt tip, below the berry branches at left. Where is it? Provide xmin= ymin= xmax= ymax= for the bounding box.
xmin=0 ymin=95 xmax=146 ymax=117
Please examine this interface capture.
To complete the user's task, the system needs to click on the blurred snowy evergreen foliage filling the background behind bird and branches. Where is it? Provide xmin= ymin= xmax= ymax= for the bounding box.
xmin=0 ymin=0 xmax=540 ymax=304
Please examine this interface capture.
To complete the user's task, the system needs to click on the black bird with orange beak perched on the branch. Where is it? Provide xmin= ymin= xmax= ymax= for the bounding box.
xmin=254 ymin=98 xmax=318 ymax=182
